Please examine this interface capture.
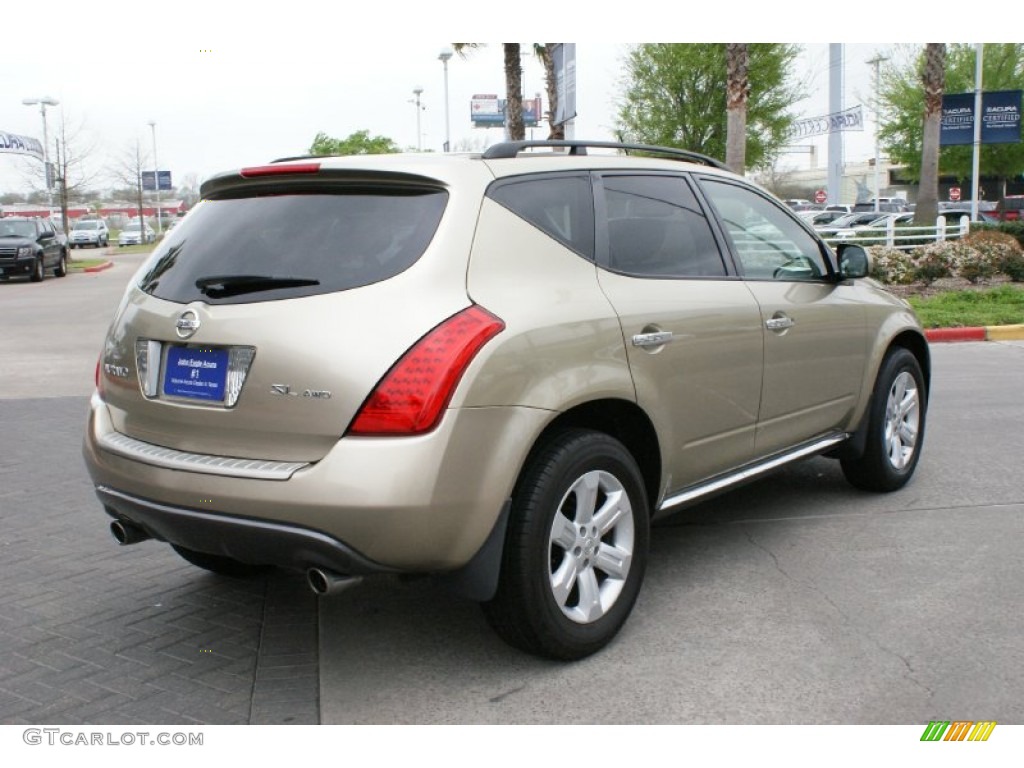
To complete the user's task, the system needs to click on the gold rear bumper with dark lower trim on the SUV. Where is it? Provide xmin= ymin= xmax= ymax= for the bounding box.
xmin=83 ymin=395 xmax=551 ymax=573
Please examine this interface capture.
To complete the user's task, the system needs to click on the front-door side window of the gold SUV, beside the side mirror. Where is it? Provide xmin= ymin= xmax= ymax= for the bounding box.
xmin=700 ymin=179 xmax=827 ymax=281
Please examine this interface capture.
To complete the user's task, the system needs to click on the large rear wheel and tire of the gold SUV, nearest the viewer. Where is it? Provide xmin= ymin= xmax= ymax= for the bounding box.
xmin=483 ymin=429 xmax=649 ymax=660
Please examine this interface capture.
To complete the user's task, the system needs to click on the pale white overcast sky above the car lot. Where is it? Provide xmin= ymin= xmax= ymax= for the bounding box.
xmin=0 ymin=6 xmax=991 ymax=198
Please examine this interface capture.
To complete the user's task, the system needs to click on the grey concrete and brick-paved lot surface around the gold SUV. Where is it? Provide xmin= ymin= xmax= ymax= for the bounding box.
xmin=0 ymin=260 xmax=1024 ymax=727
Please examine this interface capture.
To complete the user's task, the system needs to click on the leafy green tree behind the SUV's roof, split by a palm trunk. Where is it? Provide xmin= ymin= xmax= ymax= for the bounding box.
xmin=617 ymin=43 xmax=804 ymax=168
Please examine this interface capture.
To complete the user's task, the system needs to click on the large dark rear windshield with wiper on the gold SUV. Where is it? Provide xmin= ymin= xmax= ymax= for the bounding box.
xmin=139 ymin=189 xmax=447 ymax=304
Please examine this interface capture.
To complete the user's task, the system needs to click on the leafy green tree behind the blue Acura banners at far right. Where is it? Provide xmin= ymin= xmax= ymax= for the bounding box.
xmin=879 ymin=43 xmax=1024 ymax=195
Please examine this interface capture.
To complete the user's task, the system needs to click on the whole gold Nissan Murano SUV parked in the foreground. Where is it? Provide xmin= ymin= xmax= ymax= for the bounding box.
xmin=85 ymin=141 xmax=930 ymax=658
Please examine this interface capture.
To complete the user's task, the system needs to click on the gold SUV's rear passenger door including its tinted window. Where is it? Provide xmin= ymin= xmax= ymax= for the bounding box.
xmin=595 ymin=173 xmax=763 ymax=493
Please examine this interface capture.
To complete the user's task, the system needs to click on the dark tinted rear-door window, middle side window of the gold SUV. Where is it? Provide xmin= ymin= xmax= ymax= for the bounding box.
xmin=602 ymin=176 xmax=725 ymax=278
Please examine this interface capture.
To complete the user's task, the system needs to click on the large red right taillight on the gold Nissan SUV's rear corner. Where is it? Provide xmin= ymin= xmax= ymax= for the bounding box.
xmin=348 ymin=305 xmax=505 ymax=435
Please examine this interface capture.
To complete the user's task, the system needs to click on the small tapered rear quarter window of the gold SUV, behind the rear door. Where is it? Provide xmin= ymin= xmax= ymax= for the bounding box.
xmin=487 ymin=176 xmax=594 ymax=259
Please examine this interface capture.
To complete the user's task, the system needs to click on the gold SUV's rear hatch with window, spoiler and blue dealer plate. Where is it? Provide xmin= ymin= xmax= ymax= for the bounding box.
xmin=100 ymin=164 xmax=471 ymax=461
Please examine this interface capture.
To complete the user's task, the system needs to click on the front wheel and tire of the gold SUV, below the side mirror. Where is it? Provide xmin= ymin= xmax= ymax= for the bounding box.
xmin=842 ymin=347 xmax=928 ymax=493
